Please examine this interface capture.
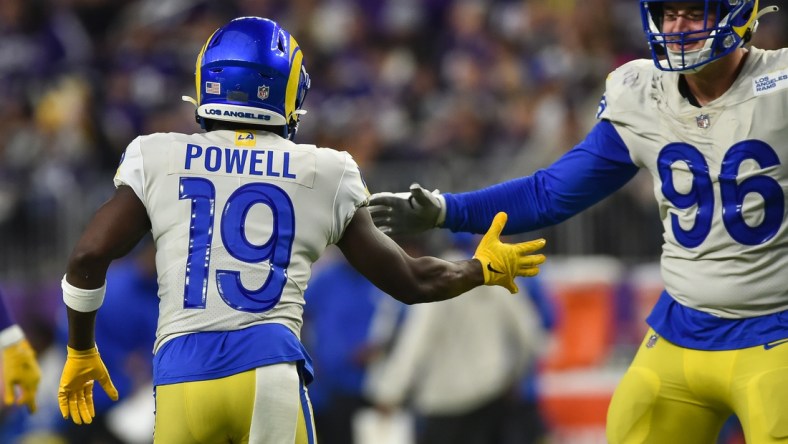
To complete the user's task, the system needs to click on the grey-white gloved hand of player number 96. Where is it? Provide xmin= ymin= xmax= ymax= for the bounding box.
xmin=369 ymin=183 xmax=445 ymax=236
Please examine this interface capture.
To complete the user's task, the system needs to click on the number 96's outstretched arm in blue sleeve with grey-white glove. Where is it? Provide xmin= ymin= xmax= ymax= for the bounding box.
xmin=370 ymin=121 xmax=638 ymax=234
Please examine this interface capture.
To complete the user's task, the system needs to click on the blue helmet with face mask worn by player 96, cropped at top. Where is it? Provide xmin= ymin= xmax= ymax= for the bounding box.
xmin=640 ymin=0 xmax=777 ymax=73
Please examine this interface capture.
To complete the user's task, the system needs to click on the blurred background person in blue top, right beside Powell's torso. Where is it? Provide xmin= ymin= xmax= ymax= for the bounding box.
xmin=303 ymin=250 xmax=406 ymax=444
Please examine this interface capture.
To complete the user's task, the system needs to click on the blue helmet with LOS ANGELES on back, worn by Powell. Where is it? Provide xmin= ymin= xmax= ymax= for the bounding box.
xmin=184 ymin=17 xmax=310 ymax=139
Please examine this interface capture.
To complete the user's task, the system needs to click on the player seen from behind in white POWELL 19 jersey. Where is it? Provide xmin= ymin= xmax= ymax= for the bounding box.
xmin=58 ymin=17 xmax=544 ymax=444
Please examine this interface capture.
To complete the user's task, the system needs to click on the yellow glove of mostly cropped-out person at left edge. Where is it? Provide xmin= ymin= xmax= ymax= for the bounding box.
xmin=3 ymin=339 xmax=41 ymax=413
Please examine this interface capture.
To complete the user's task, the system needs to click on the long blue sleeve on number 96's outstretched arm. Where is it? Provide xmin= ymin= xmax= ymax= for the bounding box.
xmin=443 ymin=120 xmax=638 ymax=234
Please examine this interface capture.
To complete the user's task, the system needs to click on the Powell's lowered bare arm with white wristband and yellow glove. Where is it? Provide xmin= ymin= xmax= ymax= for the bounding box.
xmin=58 ymin=186 xmax=150 ymax=424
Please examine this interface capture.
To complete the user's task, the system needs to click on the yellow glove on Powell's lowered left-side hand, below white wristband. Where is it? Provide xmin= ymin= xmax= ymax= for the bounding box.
xmin=57 ymin=346 xmax=118 ymax=424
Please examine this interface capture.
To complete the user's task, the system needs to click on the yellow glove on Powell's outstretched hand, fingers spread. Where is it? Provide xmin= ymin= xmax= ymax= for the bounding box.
xmin=473 ymin=213 xmax=545 ymax=294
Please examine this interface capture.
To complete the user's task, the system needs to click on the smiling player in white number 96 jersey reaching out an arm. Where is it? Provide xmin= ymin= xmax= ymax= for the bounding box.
xmin=369 ymin=0 xmax=788 ymax=444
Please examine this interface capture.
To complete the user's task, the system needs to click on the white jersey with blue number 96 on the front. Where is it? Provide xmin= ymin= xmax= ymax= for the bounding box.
xmin=599 ymin=48 xmax=788 ymax=318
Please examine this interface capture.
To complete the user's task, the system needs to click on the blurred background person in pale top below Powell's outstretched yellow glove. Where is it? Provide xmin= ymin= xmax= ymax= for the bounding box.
xmin=368 ymin=235 xmax=545 ymax=444
